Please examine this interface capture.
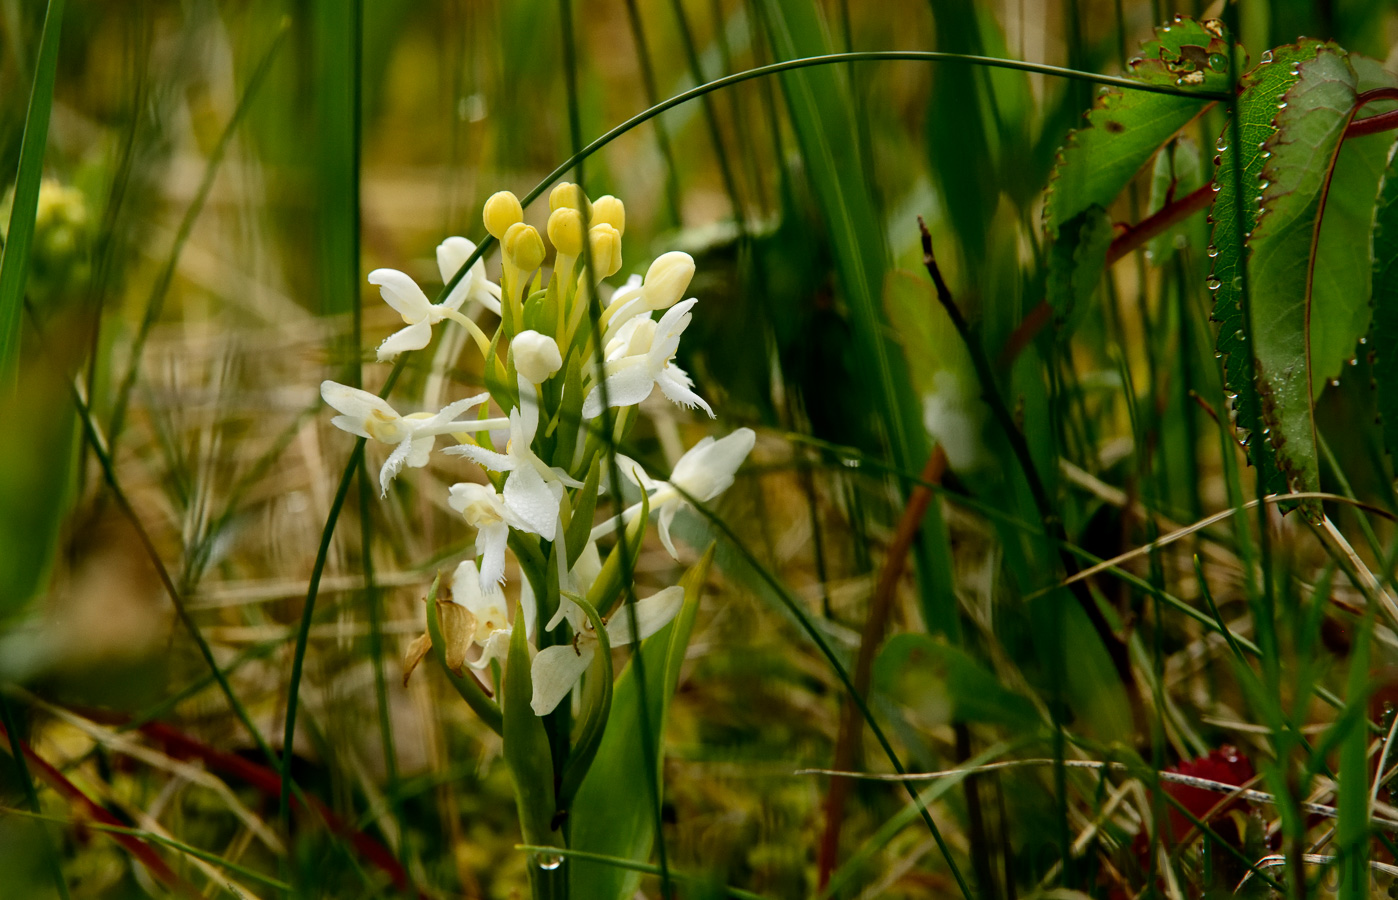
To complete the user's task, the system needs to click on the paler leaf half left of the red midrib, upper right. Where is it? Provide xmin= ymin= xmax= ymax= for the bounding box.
xmin=1248 ymin=51 xmax=1357 ymax=506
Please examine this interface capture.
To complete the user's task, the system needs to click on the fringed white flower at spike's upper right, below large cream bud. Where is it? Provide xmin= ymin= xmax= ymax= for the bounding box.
xmin=583 ymin=298 xmax=713 ymax=419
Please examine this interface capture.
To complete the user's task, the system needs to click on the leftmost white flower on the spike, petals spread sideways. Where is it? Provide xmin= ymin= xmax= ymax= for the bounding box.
xmin=320 ymin=382 xmax=505 ymax=495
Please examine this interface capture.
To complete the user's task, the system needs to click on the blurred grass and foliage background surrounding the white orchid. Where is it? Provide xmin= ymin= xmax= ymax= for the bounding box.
xmin=8 ymin=0 xmax=1398 ymax=897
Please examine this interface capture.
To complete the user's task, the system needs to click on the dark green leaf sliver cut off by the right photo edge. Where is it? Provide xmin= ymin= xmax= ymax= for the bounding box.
xmin=1369 ymin=144 xmax=1398 ymax=456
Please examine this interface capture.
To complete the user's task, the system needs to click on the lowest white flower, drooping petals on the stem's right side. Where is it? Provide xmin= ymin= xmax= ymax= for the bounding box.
xmin=530 ymin=586 xmax=685 ymax=716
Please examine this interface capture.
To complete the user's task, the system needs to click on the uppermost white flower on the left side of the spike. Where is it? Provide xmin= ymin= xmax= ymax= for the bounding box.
xmin=369 ymin=238 xmax=500 ymax=362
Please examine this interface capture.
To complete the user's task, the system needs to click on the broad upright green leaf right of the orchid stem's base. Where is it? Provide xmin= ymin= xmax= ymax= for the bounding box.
xmin=569 ymin=545 xmax=713 ymax=900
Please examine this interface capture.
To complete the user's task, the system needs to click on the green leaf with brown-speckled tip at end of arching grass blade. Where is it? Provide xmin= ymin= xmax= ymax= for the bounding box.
xmin=1044 ymin=17 xmax=1229 ymax=238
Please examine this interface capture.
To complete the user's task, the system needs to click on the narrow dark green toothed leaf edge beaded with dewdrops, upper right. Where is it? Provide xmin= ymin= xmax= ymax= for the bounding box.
xmin=1208 ymin=43 xmax=1316 ymax=493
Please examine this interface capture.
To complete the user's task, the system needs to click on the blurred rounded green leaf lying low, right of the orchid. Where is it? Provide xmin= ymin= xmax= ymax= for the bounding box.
xmin=874 ymin=633 xmax=1042 ymax=731
